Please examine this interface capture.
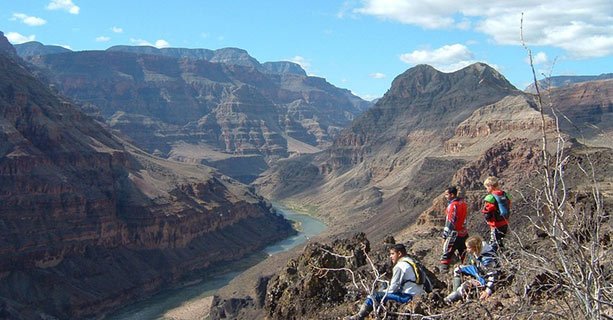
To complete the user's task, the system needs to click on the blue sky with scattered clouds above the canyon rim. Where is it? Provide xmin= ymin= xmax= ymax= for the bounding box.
xmin=0 ymin=0 xmax=613 ymax=100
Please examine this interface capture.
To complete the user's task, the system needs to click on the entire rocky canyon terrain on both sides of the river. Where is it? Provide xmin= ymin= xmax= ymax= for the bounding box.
xmin=0 ymin=28 xmax=613 ymax=319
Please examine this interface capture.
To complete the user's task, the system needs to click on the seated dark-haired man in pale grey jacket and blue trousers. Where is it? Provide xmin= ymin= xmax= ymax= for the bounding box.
xmin=346 ymin=244 xmax=424 ymax=320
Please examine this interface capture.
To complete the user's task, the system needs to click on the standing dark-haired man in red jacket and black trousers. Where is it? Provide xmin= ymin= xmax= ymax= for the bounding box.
xmin=439 ymin=187 xmax=468 ymax=272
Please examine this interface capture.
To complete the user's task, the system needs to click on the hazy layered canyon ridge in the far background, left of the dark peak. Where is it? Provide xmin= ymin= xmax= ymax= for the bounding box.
xmin=15 ymin=40 xmax=371 ymax=182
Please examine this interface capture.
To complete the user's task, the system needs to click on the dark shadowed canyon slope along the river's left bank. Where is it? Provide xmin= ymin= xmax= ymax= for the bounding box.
xmin=0 ymin=37 xmax=292 ymax=319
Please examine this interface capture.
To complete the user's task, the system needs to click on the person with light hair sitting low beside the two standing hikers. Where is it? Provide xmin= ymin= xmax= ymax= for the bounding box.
xmin=444 ymin=236 xmax=498 ymax=303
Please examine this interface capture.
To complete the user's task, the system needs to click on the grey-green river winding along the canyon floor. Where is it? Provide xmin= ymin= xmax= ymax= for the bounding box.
xmin=105 ymin=206 xmax=326 ymax=320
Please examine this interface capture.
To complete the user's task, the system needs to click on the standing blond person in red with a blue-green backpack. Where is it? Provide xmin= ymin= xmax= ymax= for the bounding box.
xmin=481 ymin=176 xmax=511 ymax=251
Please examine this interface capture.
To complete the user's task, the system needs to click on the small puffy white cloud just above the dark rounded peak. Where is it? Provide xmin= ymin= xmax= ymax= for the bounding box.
xmin=400 ymin=43 xmax=476 ymax=72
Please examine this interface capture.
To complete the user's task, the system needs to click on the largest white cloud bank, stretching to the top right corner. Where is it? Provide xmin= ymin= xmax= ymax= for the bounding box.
xmin=354 ymin=0 xmax=613 ymax=58
